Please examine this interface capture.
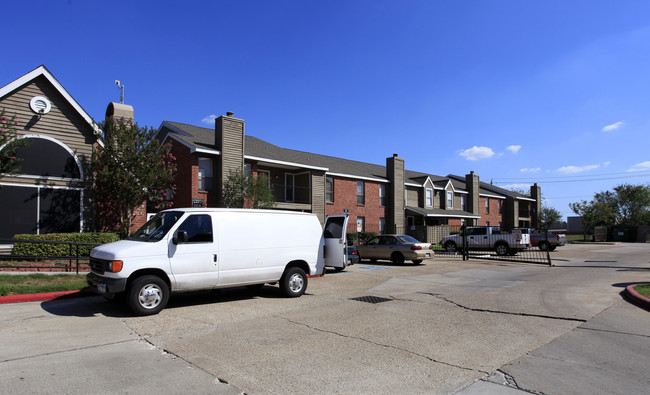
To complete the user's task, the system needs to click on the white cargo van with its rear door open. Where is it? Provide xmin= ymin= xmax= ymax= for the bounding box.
xmin=86 ymin=208 xmax=346 ymax=315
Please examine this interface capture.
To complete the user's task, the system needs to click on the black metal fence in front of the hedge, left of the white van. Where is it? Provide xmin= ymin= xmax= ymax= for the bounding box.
xmin=0 ymin=239 xmax=101 ymax=274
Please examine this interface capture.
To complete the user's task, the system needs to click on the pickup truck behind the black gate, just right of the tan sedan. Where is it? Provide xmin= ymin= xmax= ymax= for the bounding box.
xmin=440 ymin=227 xmax=530 ymax=255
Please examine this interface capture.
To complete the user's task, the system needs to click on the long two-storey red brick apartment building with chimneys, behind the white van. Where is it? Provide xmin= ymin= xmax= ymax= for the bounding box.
xmin=157 ymin=113 xmax=541 ymax=240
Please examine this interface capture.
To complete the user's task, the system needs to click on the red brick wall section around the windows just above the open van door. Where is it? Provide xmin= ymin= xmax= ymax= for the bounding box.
xmin=326 ymin=178 xmax=386 ymax=232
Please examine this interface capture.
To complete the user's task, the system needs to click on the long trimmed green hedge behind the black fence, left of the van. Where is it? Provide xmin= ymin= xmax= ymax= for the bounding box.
xmin=12 ymin=233 xmax=120 ymax=256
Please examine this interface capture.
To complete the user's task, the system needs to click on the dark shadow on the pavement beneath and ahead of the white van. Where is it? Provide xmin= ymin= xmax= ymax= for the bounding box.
xmin=41 ymin=285 xmax=302 ymax=318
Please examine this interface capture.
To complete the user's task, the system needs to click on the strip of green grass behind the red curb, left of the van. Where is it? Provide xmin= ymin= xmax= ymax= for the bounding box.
xmin=0 ymin=273 xmax=88 ymax=296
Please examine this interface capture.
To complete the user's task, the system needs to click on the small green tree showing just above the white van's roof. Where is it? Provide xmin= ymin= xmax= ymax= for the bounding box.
xmin=223 ymin=170 xmax=275 ymax=208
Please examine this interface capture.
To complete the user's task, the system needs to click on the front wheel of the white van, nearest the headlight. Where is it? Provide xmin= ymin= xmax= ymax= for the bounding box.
xmin=126 ymin=276 xmax=169 ymax=315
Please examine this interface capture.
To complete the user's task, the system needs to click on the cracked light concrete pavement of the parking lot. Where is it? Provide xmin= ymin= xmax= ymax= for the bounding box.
xmin=0 ymin=244 xmax=650 ymax=394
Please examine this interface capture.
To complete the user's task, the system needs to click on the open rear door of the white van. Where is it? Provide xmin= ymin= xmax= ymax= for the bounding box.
xmin=321 ymin=215 xmax=348 ymax=273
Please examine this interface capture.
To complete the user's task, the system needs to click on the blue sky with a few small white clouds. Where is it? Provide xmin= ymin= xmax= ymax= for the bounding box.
xmin=0 ymin=0 xmax=650 ymax=220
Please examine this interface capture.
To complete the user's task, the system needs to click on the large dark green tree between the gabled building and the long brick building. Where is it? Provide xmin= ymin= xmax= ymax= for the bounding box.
xmin=93 ymin=118 xmax=176 ymax=237
